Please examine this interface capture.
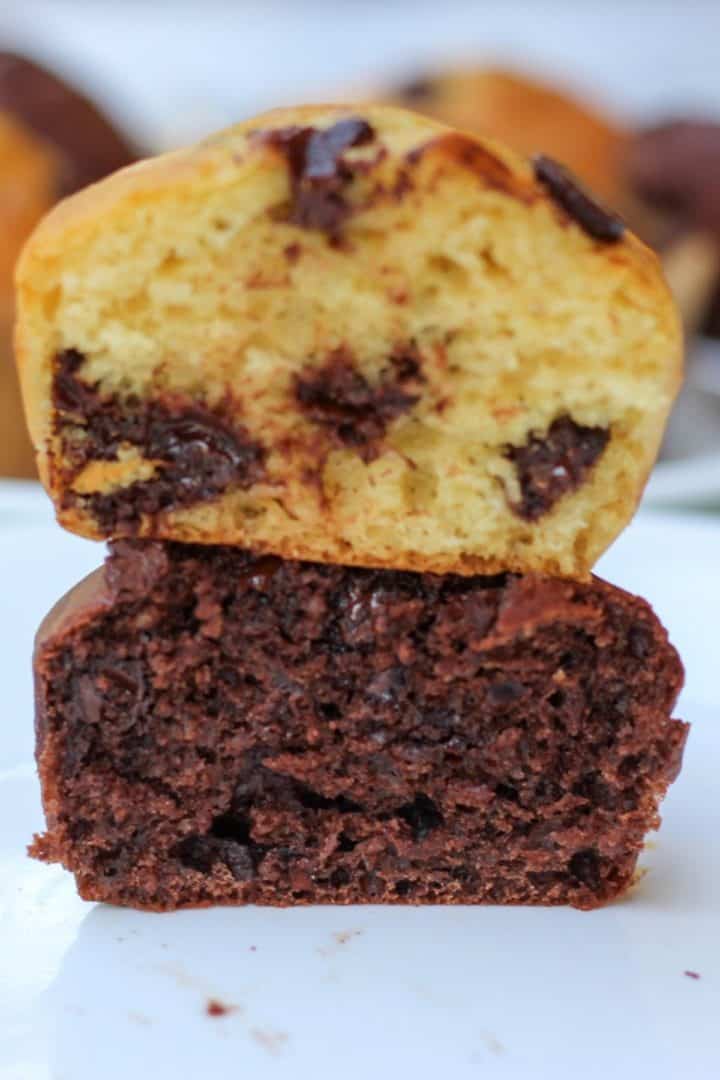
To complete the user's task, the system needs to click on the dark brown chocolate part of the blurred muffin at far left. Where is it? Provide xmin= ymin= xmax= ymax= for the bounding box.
xmin=0 ymin=53 xmax=138 ymax=195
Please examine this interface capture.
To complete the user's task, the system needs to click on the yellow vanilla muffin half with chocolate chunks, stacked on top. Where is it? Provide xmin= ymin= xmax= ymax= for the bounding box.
xmin=16 ymin=106 xmax=681 ymax=577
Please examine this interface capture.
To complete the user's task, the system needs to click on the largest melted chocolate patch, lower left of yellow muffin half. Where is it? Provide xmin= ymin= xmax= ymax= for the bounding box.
xmin=53 ymin=349 xmax=264 ymax=535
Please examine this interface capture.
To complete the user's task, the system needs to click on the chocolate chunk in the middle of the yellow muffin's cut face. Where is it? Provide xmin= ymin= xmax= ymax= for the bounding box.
xmin=295 ymin=349 xmax=424 ymax=460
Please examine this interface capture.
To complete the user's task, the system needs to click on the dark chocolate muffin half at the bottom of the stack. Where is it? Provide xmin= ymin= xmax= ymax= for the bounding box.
xmin=31 ymin=541 xmax=687 ymax=909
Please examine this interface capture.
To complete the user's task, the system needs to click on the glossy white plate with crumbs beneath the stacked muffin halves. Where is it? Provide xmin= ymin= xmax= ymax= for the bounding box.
xmin=0 ymin=515 xmax=720 ymax=1080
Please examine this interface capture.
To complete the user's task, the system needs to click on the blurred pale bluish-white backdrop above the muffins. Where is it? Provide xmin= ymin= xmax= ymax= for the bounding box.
xmin=0 ymin=0 xmax=720 ymax=147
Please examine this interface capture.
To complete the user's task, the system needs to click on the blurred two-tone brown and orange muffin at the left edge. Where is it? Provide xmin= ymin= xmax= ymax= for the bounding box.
xmin=0 ymin=52 xmax=137 ymax=477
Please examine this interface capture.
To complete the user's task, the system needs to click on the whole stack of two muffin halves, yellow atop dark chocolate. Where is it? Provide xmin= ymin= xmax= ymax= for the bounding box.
xmin=17 ymin=106 xmax=687 ymax=908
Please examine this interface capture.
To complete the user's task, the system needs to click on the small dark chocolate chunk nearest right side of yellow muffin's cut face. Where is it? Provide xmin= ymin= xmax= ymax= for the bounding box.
xmin=505 ymin=416 xmax=610 ymax=522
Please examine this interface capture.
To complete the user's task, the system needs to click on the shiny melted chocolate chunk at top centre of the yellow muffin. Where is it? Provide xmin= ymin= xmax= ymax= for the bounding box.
xmin=259 ymin=117 xmax=375 ymax=240
